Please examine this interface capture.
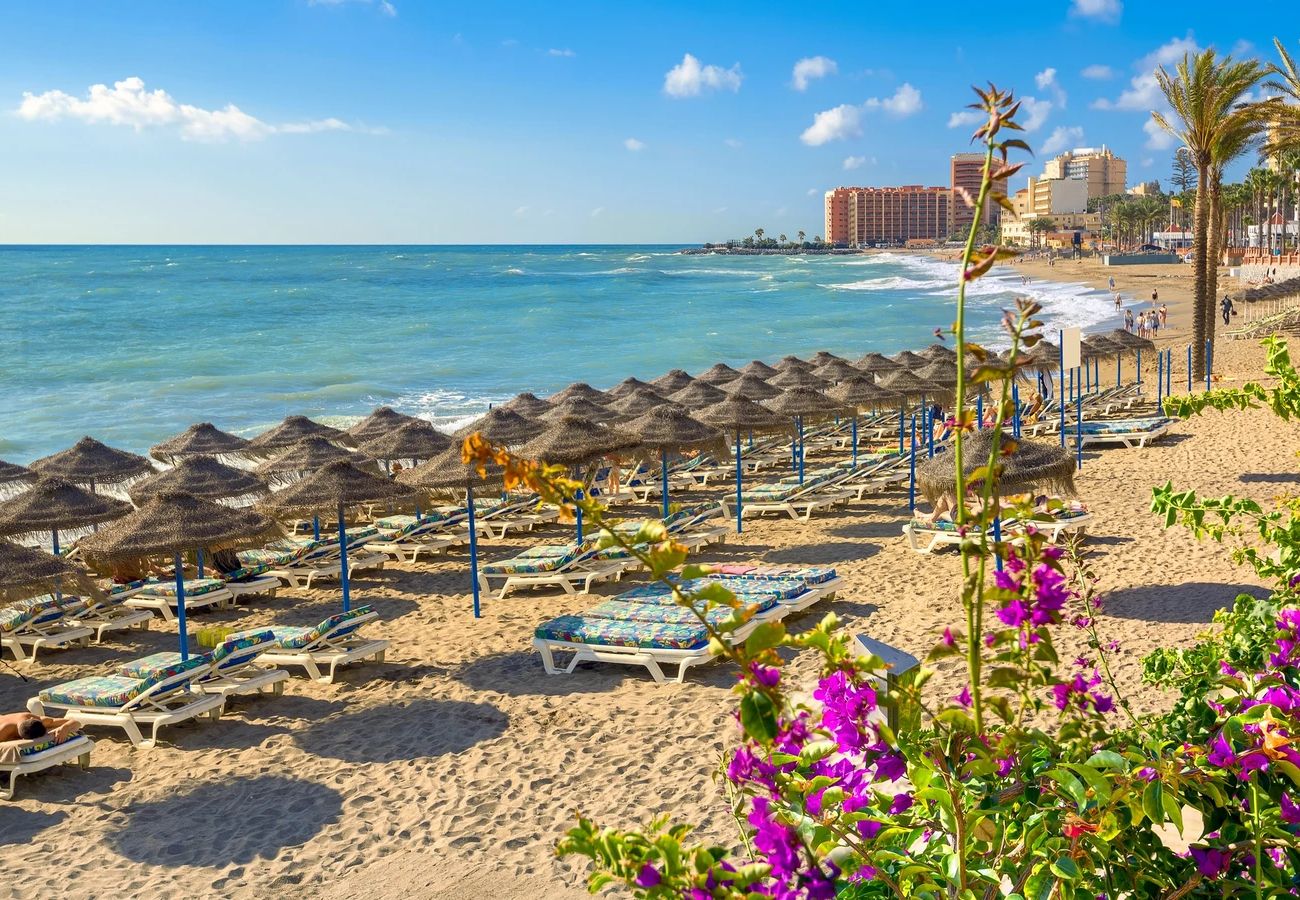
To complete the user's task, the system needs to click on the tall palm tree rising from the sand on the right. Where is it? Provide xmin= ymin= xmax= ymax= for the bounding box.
xmin=1152 ymin=49 xmax=1265 ymax=375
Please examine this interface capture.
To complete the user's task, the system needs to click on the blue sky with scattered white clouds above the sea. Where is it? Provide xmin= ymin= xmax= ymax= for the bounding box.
xmin=0 ymin=0 xmax=1300 ymax=243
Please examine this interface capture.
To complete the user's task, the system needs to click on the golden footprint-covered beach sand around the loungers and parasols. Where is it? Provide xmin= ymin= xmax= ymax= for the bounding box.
xmin=0 ymin=318 xmax=1300 ymax=900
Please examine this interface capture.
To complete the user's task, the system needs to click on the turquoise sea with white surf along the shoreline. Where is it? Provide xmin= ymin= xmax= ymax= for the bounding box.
xmin=0 ymin=246 xmax=1117 ymax=463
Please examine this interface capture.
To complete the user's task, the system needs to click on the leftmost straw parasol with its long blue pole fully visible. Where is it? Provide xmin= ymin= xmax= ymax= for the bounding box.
xmin=81 ymin=490 xmax=276 ymax=659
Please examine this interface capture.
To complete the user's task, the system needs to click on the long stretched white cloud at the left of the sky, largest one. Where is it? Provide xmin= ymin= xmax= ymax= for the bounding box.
xmin=17 ymin=75 xmax=380 ymax=142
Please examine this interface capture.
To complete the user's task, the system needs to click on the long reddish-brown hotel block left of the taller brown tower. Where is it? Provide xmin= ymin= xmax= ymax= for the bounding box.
xmin=826 ymin=185 xmax=953 ymax=247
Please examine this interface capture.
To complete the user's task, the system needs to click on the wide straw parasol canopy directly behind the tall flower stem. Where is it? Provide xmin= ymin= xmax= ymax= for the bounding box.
xmin=917 ymin=430 xmax=1075 ymax=502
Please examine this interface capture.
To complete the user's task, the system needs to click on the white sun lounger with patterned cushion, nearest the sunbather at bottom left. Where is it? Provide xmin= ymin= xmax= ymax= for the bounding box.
xmin=27 ymin=655 xmax=225 ymax=748
